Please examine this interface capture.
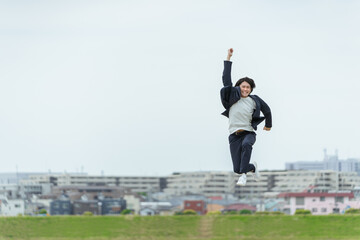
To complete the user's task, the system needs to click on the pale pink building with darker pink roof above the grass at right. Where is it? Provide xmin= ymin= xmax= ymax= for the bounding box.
xmin=278 ymin=192 xmax=360 ymax=215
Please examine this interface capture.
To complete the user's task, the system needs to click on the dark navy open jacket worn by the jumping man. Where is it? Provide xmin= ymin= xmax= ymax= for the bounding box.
xmin=220 ymin=61 xmax=272 ymax=130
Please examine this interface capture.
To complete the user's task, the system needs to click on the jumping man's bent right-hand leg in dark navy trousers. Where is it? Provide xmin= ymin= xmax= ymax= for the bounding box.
xmin=240 ymin=132 xmax=256 ymax=173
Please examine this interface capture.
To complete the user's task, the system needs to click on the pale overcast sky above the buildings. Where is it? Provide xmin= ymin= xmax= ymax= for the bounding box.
xmin=0 ymin=0 xmax=360 ymax=176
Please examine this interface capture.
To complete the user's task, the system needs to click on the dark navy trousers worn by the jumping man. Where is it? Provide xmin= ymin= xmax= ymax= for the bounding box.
xmin=229 ymin=131 xmax=256 ymax=174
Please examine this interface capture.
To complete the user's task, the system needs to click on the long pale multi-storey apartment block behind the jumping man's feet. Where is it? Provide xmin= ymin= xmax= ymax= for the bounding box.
xmin=164 ymin=170 xmax=360 ymax=199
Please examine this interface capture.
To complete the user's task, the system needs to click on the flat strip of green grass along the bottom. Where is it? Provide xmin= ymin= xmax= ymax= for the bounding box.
xmin=0 ymin=215 xmax=360 ymax=240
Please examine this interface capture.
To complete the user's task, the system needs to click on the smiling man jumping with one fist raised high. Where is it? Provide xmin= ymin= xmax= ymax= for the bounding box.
xmin=220 ymin=48 xmax=272 ymax=186
